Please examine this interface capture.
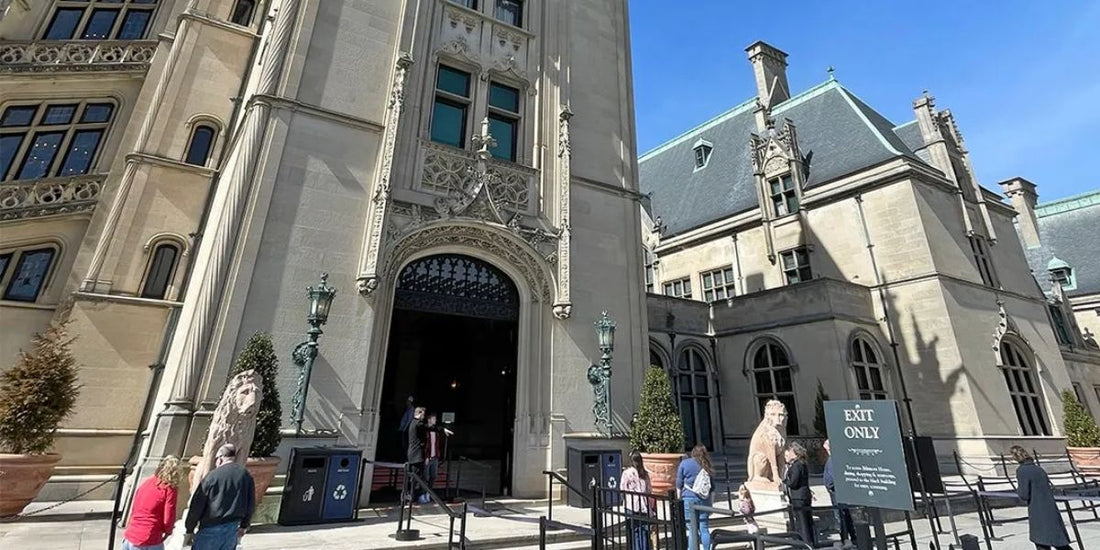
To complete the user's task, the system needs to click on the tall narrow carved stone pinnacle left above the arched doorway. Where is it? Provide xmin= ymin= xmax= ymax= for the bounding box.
xmin=355 ymin=54 xmax=413 ymax=296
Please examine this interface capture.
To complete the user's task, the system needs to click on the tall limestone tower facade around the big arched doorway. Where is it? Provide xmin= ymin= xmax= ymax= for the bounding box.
xmin=0 ymin=0 xmax=647 ymax=498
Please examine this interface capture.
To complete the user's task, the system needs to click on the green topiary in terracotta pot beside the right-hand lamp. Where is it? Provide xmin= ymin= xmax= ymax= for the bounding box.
xmin=630 ymin=366 xmax=684 ymax=494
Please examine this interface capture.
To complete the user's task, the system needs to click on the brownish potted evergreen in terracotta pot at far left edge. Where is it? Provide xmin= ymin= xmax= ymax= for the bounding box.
xmin=0 ymin=322 xmax=80 ymax=517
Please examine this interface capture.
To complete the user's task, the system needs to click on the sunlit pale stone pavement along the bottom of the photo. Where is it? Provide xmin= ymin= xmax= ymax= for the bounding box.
xmin=0 ymin=501 xmax=1100 ymax=550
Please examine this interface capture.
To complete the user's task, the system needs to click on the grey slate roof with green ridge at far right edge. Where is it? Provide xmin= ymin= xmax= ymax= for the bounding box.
xmin=1024 ymin=190 xmax=1100 ymax=297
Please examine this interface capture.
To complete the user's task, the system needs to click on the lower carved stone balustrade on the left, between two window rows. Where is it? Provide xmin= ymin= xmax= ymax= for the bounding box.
xmin=0 ymin=174 xmax=107 ymax=221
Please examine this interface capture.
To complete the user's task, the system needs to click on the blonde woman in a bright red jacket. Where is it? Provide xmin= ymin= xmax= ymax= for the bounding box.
xmin=122 ymin=455 xmax=187 ymax=550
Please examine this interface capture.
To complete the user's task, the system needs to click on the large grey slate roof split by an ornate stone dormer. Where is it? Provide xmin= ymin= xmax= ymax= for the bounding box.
xmin=638 ymin=79 xmax=921 ymax=237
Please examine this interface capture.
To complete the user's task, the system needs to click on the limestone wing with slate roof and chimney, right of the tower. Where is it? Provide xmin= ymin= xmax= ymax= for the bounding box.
xmin=639 ymin=43 xmax=1100 ymax=469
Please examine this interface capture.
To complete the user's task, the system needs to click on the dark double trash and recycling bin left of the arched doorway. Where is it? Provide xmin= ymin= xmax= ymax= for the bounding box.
xmin=278 ymin=447 xmax=363 ymax=525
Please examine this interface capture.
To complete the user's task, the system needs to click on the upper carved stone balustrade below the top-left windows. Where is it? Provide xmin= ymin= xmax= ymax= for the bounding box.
xmin=0 ymin=40 xmax=157 ymax=72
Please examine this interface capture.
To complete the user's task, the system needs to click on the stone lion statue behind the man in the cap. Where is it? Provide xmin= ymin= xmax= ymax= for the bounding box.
xmin=191 ymin=371 xmax=263 ymax=493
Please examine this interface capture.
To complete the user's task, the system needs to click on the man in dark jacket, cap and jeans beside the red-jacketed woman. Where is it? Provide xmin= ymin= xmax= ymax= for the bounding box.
xmin=184 ymin=444 xmax=256 ymax=550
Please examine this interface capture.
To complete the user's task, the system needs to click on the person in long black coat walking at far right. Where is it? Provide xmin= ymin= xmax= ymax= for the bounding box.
xmin=1009 ymin=446 xmax=1069 ymax=550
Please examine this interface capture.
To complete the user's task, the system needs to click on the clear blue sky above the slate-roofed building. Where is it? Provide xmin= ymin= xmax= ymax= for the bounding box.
xmin=630 ymin=0 xmax=1100 ymax=202
